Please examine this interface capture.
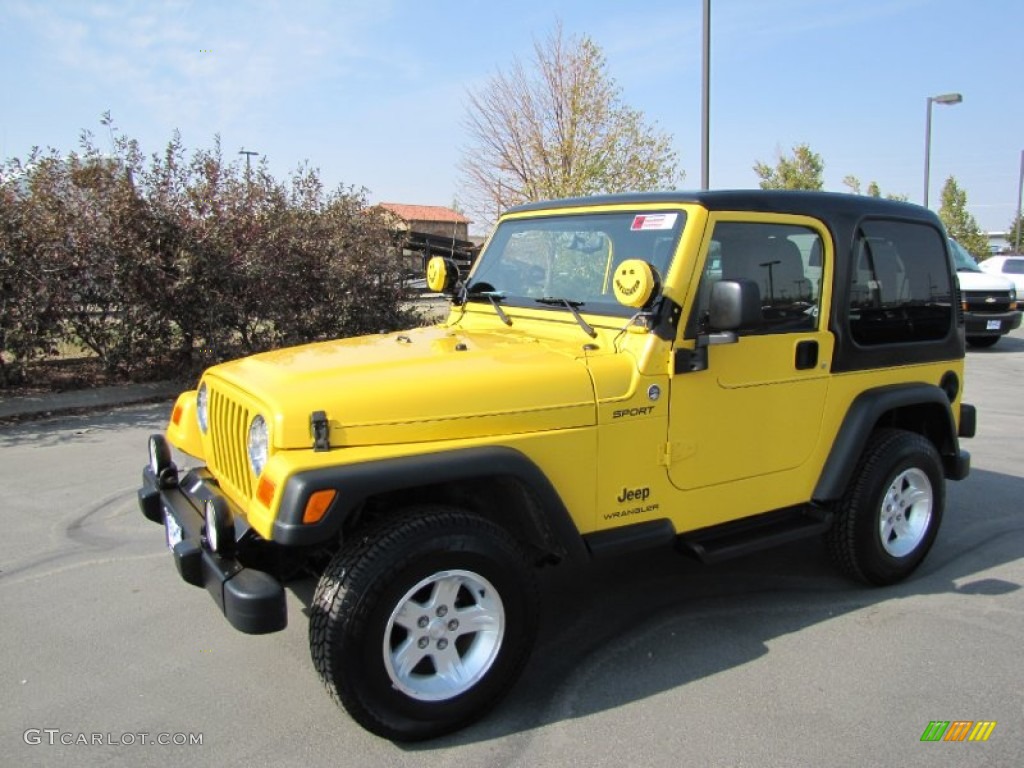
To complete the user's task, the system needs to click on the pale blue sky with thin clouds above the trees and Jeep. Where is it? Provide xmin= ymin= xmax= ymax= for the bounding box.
xmin=0 ymin=0 xmax=1024 ymax=230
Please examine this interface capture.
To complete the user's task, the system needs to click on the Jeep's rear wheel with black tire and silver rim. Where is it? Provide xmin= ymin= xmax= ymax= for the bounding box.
xmin=825 ymin=429 xmax=945 ymax=586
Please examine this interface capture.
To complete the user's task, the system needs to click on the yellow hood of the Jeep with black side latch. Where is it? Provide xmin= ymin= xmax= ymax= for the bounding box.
xmin=205 ymin=328 xmax=596 ymax=449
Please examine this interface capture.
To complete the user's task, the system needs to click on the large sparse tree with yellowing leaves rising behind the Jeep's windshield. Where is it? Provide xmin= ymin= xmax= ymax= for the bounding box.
xmin=461 ymin=25 xmax=683 ymax=221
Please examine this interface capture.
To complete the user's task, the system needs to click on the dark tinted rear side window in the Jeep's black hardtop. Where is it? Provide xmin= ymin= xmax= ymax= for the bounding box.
xmin=849 ymin=220 xmax=953 ymax=345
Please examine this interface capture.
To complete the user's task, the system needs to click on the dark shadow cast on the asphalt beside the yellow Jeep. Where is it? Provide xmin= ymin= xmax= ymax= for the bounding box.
xmin=366 ymin=471 xmax=1024 ymax=752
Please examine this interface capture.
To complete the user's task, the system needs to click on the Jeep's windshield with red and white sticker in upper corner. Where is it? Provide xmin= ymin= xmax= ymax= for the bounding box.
xmin=467 ymin=211 xmax=686 ymax=315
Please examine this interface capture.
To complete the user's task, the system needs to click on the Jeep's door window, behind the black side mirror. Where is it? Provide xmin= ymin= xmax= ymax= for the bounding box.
xmin=687 ymin=221 xmax=823 ymax=336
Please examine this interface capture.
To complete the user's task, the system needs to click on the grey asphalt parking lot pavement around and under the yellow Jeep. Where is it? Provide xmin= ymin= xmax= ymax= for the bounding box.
xmin=0 ymin=331 xmax=1024 ymax=768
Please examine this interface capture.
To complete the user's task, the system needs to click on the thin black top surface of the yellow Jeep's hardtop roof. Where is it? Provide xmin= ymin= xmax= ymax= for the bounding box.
xmin=508 ymin=189 xmax=939 ymax=224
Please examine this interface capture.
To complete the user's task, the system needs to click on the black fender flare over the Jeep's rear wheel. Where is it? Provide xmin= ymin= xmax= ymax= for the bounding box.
xmin=812 ymin=383 xmax=962 ymax=504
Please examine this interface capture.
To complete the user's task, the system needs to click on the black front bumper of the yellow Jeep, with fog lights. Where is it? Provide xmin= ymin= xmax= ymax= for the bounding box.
xmin=138 ymin=465 xmax=288 ymax=635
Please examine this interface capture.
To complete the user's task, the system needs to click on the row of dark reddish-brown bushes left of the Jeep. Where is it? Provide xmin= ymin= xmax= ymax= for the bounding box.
xmin=0 ymin=132 xmax=417 ymax=386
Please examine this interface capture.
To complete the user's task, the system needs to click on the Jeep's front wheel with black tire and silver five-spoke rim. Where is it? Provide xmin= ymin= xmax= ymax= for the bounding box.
xmin=309 ymin=506 xmax=539 ymax=741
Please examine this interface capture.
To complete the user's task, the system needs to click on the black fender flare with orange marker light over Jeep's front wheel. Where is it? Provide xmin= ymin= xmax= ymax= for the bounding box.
xmin=272 ymin=445 xmax=588 ymax=558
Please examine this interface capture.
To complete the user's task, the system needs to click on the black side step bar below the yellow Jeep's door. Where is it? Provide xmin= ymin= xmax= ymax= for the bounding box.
xmin=677 ymin=507 xmax=833 ymax=563
